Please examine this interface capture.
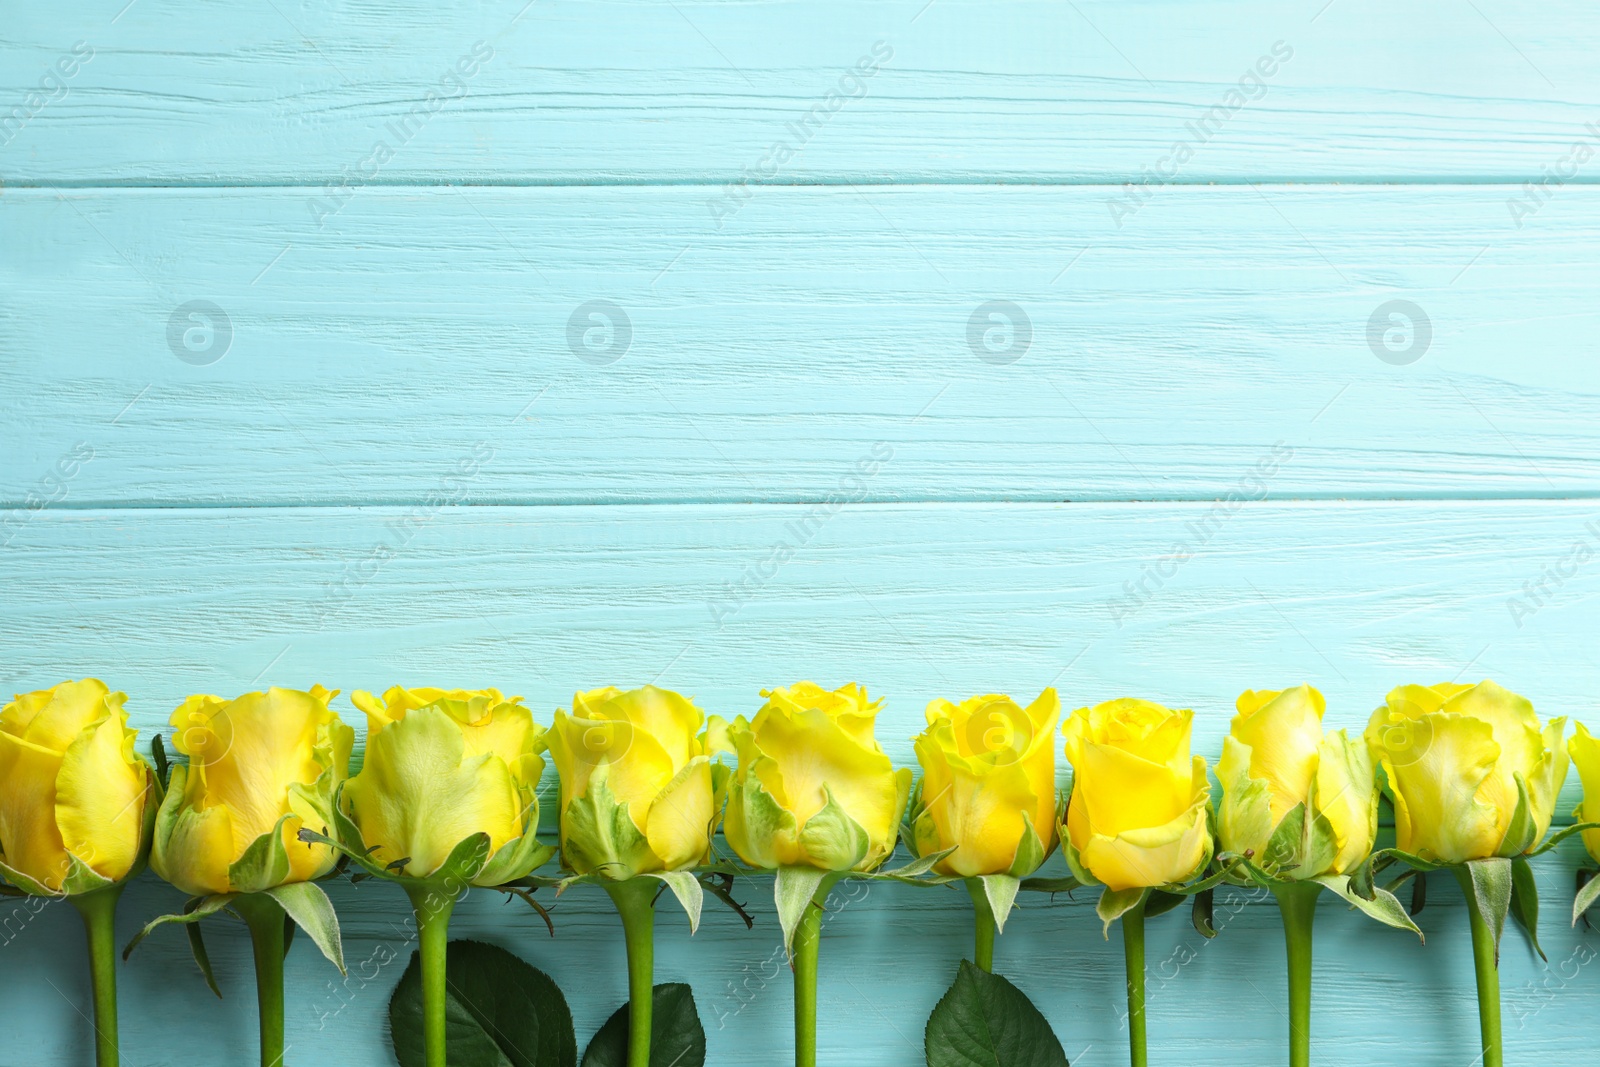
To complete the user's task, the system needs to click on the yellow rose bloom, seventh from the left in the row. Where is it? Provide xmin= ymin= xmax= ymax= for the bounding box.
xmin=1061 ymin=697 xmax=1211 ymax=889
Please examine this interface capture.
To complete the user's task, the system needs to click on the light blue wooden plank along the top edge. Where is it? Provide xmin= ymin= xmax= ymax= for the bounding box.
xmin=0 ymin=0 xmax=1600 ymax=187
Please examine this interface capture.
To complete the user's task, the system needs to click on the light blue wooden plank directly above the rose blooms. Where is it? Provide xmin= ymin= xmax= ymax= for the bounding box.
xmin=0 ymin=501 xmax=1600 ymax=800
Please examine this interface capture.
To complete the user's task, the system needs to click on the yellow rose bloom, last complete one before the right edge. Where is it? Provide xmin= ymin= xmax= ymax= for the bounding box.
xmin=1366 ymin=681 xmax=1566 ymax=864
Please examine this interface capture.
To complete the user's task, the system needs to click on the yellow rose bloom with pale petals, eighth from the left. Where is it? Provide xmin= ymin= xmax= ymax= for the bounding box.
xmin=1216 ymin=685 xmax=1378 ymax=880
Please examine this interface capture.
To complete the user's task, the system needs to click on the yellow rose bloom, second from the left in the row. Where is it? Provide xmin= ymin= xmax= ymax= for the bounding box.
xmin=150 ymin=686 xmax=355 ymax=896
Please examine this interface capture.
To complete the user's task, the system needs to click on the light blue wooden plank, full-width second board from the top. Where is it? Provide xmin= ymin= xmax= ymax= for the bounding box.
xmin=0 ymin=183 xmax=1600 ymax=508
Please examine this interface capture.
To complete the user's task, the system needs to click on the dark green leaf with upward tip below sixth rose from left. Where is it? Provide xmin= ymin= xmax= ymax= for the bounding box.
xmin=923 ymin=960 xmax=1067 ymax=1067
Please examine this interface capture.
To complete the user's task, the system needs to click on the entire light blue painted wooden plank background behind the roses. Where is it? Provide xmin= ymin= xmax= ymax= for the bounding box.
xmin=0 ymin=0 xmax=1600 ymax=1067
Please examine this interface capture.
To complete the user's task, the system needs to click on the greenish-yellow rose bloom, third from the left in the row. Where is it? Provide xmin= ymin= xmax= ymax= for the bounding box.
xmin=342 ymin=686 xmax=549 ymax=886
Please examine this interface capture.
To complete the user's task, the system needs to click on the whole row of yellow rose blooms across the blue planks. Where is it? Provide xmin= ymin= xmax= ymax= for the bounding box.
xmin=0 ymin=680 xmax=1600 ymax=894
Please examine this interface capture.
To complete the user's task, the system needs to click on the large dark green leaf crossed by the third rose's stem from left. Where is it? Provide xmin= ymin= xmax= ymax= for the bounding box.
xmin=389 ymin=941 xmax=578 ymax=1067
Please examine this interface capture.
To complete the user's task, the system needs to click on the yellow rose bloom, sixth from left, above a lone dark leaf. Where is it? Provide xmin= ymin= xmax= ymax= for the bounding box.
xmin=912 ymin=689 xmax=1061 ymax=878
